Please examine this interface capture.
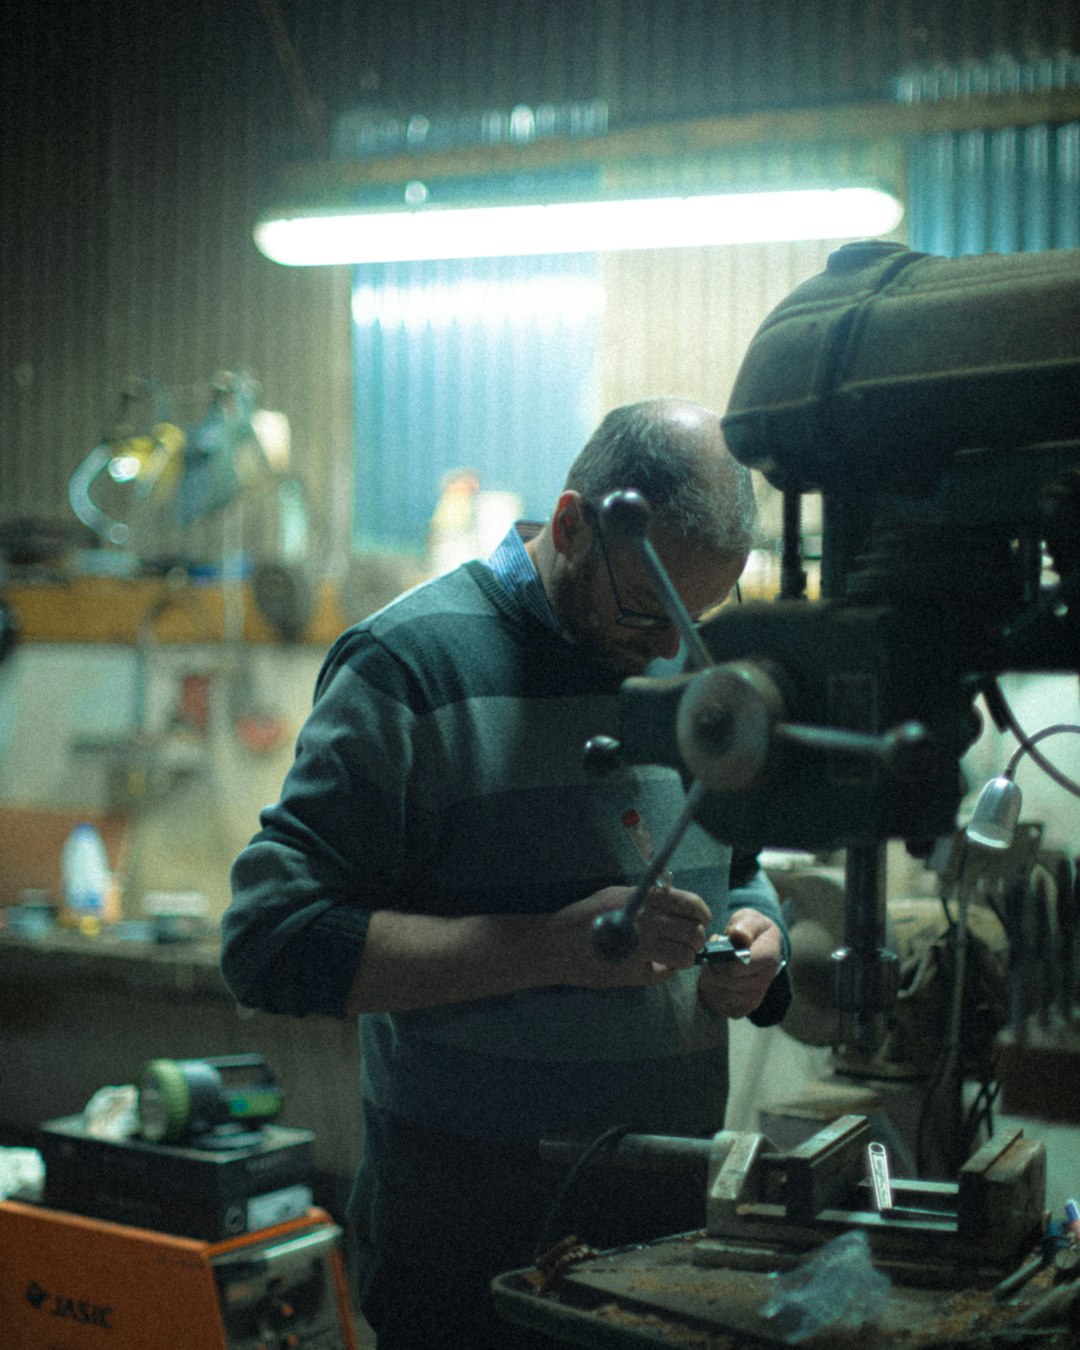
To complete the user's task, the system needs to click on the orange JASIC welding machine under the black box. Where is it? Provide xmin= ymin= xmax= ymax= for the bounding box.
xmin=0 ymin=1200 xmax=359 ymax=1350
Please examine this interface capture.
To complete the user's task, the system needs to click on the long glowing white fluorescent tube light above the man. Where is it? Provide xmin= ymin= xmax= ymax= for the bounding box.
xmin=255 ymin=185 xmax=903 ymax=267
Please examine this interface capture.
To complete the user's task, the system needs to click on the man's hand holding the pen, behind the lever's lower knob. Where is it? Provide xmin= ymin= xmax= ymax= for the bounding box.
xmin=545 ymin=886 xmax=707 ymax=988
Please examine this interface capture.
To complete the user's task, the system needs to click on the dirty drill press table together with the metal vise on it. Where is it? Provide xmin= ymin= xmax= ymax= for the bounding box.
xmin=493 ymin=1115 xmax=1053 ymax=1350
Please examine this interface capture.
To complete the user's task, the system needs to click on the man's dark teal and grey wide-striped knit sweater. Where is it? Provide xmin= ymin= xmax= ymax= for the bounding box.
xmin=221 ymin=563 xmax=779 ymax=1161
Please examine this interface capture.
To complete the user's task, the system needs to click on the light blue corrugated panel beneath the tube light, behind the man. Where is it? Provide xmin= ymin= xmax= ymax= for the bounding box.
xmin=352 ymin=254 xmax=602 ymax=551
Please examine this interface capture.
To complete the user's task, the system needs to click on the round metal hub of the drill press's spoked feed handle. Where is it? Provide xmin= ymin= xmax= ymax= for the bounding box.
xmin=675 ymin=662 xmax=784 ymax=792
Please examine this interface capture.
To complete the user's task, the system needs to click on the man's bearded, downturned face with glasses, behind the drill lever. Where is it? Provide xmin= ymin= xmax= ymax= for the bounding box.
xmin=552 ymin=527 xmax=744 ymax=678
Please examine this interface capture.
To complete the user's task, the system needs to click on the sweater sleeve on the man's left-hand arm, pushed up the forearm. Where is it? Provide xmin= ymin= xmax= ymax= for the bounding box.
xmin=221 ymin=633 xmax=423 ymax=1017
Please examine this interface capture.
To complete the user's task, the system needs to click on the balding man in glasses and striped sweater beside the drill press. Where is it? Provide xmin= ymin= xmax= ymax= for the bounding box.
xmin=223 ymin=398 xmax=786 ymax=1350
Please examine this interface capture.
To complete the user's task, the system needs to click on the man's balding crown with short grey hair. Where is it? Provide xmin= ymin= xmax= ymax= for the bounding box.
xmin=566 ymin=398 xmax=757 ymax=558
